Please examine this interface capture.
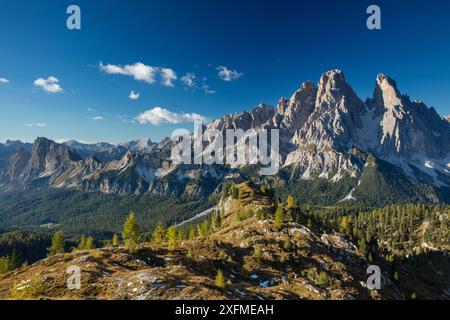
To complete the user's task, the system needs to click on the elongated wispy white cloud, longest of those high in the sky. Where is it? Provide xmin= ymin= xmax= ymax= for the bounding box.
xmin=99 ymin=62 xmax=177 ymax=87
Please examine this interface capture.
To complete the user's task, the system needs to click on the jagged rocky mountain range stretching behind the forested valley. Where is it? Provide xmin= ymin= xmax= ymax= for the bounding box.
xmin=0 ymin=70 xmax=450 ymax=205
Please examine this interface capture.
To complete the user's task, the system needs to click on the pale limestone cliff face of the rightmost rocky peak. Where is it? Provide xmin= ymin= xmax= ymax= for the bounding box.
xmin=368 ymin=74 xmax=450 ymax=159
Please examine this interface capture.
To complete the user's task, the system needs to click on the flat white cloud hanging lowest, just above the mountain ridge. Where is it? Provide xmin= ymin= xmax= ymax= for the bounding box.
xmin=136 ymin=107 xmax=208 ymax=126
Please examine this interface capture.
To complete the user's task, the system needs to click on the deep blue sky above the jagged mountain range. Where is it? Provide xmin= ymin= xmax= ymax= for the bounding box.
xmin=0 ymin=0 xmax=450 ymax=142
